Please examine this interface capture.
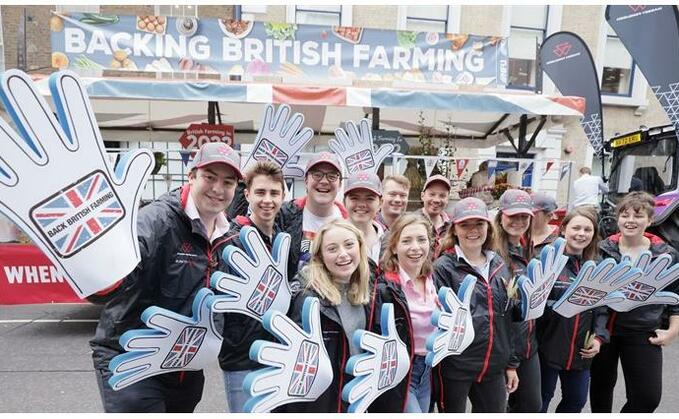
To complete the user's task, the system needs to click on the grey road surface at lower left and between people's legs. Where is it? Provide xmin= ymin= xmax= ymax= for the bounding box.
xmin=0 ymin=304 xmax=679 ymax=413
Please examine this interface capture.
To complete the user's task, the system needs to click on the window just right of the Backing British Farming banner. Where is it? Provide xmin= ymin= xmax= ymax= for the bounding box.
xmin=507 ymin=6 xmax=549 ymax=89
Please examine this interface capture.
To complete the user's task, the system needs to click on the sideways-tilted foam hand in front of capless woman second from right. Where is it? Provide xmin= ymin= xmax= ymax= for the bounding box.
xmin=552 ymin=258 xmax=643 ymax=317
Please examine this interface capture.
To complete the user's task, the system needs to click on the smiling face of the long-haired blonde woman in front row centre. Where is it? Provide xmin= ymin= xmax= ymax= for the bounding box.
xmin=321 ymin=227 xmax=360 ymax=283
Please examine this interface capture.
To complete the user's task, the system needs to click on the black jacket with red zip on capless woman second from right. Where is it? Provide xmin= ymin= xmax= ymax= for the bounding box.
xmin=537 ymin=255 xmax=610 ymax=371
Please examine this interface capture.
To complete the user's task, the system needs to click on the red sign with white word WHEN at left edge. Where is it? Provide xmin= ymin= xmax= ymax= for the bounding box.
xmin=0 ymin=244 xmax=83 ymax=304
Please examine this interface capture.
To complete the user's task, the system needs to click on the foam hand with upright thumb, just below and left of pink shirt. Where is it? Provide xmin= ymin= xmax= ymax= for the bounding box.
xmin=342 ymin=304 xmax=410 ymax=413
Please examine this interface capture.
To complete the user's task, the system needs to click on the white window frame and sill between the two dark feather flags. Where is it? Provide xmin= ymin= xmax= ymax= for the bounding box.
xmin=594 ymin=6 xmax=648 ymax=109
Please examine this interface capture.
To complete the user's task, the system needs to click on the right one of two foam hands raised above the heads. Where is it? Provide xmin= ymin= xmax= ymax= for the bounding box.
xmin=328 ymin=119 xmax=394 ymax=174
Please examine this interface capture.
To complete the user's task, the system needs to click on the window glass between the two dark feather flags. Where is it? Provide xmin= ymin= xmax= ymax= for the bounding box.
xmin=601 ymin=23 xmax=636 ymax=96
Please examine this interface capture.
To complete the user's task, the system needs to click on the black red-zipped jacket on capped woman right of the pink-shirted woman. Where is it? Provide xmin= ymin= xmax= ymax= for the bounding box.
xmin=434 ymin=249 xmax=521 ymax=383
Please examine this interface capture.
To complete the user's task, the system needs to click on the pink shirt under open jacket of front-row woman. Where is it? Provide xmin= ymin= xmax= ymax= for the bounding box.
xmin=399 ymin=269 xmax=437 ymax=355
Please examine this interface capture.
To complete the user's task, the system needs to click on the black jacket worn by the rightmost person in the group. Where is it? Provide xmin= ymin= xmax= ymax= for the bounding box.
xmin=599 ymin=233 xmax=679 ymax=340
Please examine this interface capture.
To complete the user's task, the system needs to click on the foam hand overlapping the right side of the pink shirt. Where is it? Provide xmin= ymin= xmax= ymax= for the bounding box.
xmin=425 ymin=275 xmax=476 ymax=367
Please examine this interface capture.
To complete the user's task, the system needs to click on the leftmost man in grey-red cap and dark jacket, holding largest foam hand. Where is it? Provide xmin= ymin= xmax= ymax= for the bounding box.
xmin=90 ymin=143 xmax=243 ymax=413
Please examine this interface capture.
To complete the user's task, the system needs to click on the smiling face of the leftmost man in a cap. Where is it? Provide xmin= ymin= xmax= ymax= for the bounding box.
xmin=189 ymin=163 xmax=236 ymax=218
